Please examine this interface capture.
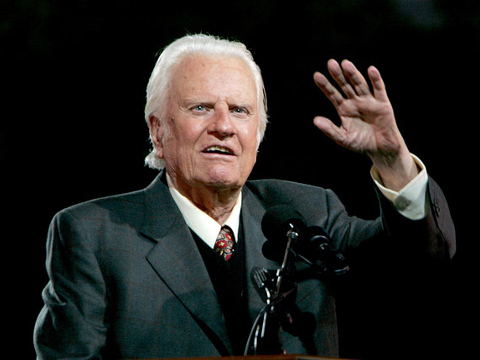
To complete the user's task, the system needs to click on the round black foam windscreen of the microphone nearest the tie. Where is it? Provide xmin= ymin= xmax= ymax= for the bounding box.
xmin=262 ymin=205 xmax=306 ymax=242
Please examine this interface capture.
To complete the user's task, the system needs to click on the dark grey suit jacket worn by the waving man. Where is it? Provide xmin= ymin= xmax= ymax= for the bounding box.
xmin=34 ymin=175 xmax=455 ymax=359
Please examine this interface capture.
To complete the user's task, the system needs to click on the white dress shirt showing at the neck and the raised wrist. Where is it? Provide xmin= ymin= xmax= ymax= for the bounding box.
xmin=167 ymin=154 xmax=428 ymax=249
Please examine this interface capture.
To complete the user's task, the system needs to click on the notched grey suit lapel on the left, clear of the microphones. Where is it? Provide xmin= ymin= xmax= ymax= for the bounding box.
xmin=142 ymin=175 xmax=231 ymax=352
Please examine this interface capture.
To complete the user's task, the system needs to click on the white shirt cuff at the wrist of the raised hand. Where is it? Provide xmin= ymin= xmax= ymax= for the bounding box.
xmin=370 ymin=154 xmax=428 ymax=220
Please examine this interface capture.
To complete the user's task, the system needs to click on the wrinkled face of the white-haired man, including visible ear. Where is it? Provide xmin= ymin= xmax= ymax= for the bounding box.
xmin=155 ymin=56 xmax=258 ymax=192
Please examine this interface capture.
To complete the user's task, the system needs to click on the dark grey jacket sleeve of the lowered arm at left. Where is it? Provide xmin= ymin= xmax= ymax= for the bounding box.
xmin=34 ymin=211 xmax=107 ymax=359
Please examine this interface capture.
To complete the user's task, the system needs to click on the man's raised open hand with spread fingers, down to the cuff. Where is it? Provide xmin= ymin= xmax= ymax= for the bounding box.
xmin=314 ymin=60 xmax=418 ymax=190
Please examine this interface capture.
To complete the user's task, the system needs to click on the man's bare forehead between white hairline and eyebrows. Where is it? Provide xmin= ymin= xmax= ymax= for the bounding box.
xmin=172 ymin=56 xmax=257 ymax=102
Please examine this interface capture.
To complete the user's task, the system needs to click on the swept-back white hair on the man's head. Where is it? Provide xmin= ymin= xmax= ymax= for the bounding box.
xmin=145 ymin=34 xmax=267 ymax=169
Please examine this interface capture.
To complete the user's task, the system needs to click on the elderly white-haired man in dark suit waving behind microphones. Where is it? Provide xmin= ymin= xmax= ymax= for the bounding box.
xmin=35 ymin=35 xmax=455 ymax=359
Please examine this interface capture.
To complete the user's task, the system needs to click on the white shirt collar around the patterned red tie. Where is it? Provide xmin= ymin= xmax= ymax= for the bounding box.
xmin=167 ymin=173 xmax=242 ymax=249
